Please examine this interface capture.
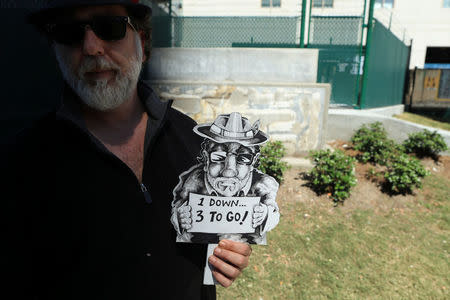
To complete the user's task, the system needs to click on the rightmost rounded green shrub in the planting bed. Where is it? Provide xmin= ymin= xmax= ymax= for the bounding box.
xmin=384 ymin=153 xmax=429 ymax=194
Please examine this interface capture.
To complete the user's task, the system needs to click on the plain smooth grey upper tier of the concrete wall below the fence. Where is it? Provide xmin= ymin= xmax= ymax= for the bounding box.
xmin=146 ymin=48 xmax=319 ymax=83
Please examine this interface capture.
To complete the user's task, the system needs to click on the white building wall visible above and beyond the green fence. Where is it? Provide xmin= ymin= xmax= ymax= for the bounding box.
xmin=182 ymin=0 xmax=450 ymax=68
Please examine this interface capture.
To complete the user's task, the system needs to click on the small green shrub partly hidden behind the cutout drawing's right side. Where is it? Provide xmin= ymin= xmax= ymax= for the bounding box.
xmin=258 ymin=141 xmax=289 ymax=184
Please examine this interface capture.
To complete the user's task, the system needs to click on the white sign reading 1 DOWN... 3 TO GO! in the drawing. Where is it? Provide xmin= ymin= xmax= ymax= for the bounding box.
xmin=188 ymin=193 xmax=260 ymax=233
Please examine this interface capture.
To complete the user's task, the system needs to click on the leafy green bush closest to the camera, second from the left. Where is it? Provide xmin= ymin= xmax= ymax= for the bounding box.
xmin=308 ymin=149 xmax=356 ymax=203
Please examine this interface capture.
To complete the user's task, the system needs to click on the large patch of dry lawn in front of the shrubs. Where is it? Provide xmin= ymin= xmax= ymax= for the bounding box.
xmin=217 ymin=171 xmax=450 ymax=300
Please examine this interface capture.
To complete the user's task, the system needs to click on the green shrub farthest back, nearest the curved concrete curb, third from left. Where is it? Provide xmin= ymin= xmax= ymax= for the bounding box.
xmin=351 ymin=122 xmax=401 ymax=165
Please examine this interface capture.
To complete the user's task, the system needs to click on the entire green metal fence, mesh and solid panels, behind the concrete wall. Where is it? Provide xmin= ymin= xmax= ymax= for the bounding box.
xmin=153 ymin=0 xmax=409 ymax=108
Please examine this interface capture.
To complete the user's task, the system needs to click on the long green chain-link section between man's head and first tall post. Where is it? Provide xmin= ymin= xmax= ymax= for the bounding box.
xmin=153 ymin=17 xmax=300 ymax=48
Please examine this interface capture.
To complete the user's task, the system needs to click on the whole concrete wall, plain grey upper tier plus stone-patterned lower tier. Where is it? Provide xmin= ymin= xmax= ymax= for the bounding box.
xmin=148 ymin=48 xmax=331 ymax=156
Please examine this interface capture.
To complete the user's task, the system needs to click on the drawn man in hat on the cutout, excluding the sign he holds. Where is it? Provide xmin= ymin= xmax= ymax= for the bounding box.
xmin=171 ymin=112 xmax=280 ymax=244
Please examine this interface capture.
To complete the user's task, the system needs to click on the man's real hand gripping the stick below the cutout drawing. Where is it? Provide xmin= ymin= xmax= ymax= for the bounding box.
xmin=208 ymin=240 xmax=252 ymax=287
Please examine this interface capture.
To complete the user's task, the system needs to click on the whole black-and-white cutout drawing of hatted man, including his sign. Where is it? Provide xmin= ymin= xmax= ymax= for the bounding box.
xmin=171 ymin=112 xmax=280 ymax=244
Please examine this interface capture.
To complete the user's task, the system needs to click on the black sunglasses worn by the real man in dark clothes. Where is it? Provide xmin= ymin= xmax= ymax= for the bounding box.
xmin=46 ymin=16 xmax=136 ymax=46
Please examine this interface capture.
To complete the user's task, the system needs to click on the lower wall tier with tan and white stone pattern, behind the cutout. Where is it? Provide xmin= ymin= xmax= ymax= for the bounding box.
xmin=151 ymin=81 xmax=330 ymax=156
